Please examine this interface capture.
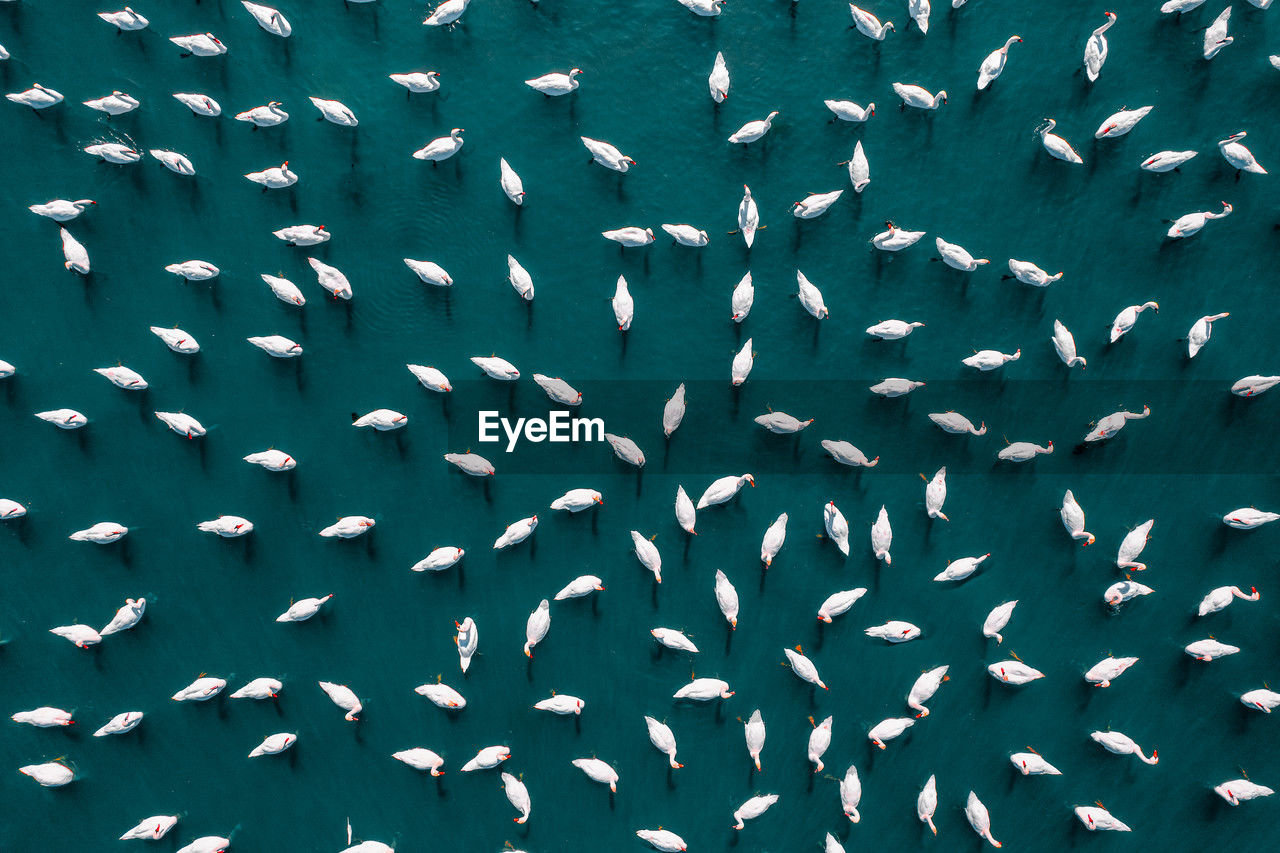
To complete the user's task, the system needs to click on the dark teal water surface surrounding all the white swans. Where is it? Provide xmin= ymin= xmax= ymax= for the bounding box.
xmin=0 ymin=0 xmax=1280 ymax=852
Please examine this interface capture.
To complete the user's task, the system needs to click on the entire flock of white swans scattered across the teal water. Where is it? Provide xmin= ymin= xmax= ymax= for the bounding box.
xmin=0 ymin=0 xmax=1280 ymax=853
